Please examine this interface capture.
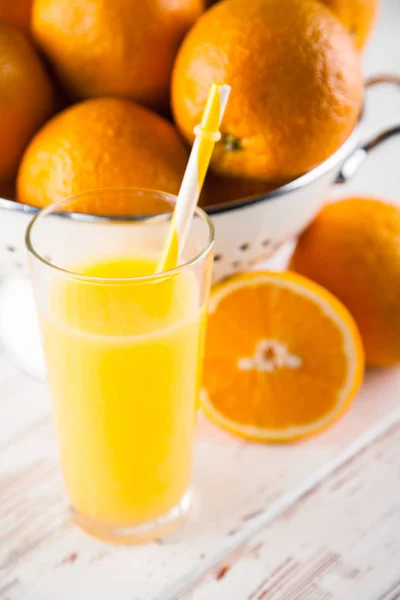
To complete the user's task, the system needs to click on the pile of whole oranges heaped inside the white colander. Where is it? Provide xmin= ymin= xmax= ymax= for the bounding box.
xmin=0 ymin=0 xmax=376 ymax=208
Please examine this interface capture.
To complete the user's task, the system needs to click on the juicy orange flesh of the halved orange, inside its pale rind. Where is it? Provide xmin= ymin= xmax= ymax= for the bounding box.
xmin=204 ymin=274 xmax=364 ymax=430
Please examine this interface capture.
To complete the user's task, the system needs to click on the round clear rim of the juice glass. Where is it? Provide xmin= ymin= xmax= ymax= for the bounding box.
xmin=25 ymin=187 xmax=215 ymax=283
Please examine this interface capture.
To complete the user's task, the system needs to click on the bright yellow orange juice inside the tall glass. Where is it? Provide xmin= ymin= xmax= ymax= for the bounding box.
xmin=41 ymin=258 xmax=205 ymax=525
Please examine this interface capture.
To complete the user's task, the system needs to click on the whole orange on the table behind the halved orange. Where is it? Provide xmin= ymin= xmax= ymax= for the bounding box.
xmin=291 ymin=198 xmax=400 ymax=365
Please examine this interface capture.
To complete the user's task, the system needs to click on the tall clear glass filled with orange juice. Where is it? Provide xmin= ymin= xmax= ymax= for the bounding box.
xmin=26 ymin=189 xmax=213 ymax=543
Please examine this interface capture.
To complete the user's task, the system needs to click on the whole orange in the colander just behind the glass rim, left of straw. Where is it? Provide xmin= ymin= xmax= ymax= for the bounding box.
xmin=17 ymin=98 xmax=188 ymax=212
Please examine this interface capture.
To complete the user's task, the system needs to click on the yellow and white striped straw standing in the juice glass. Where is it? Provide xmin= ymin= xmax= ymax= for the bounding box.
xmin=157 ymin=83 xmax=231 ymax=272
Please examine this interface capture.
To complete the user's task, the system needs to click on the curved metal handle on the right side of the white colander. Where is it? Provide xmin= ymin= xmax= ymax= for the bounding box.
xmin=335 ymin=73 xmax=400 ymax=183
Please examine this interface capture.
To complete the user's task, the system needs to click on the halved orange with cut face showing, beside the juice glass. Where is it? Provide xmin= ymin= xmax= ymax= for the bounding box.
xmin=201 ymin=272 xmax=364 ymax=442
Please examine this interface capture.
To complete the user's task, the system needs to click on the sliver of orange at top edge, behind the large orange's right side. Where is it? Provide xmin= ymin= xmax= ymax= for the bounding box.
xmin=320 ymin=0 xmax=379 ymax=49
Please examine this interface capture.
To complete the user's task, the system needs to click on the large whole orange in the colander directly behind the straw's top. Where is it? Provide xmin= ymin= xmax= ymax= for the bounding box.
xmin=172 ymin=0 xmax=363 ymax=182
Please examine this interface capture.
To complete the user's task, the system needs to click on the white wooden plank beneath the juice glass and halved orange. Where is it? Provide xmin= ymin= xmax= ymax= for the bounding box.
xmin=0 ymin=356 xmax=400 ymax=600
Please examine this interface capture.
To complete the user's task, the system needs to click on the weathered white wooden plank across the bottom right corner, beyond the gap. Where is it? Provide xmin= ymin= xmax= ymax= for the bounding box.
xmin=180 ymin=424 xmax=400 ymax=600
